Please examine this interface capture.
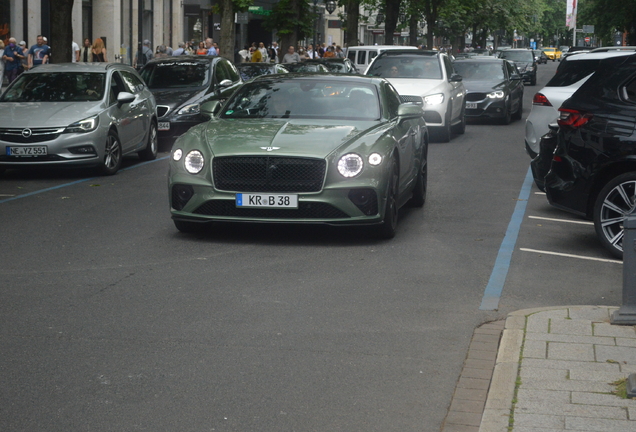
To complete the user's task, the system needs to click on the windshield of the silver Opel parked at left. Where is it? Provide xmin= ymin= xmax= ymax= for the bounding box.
xmin=0 ymin=72 xmax=106 ymax=102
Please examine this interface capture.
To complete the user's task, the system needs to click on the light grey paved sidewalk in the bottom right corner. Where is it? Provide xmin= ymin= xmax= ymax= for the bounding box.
xmin=482 ymin=306 xmax=636 ymax=432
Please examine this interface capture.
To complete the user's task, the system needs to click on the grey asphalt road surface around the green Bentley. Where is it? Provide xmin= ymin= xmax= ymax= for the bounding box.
xmin=0 ymin=63 xmax=622 ymax=432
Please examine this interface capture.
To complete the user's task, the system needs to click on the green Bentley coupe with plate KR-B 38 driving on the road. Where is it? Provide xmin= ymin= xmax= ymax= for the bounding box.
xmin=169 ymin=74 xmax=428 ymax=238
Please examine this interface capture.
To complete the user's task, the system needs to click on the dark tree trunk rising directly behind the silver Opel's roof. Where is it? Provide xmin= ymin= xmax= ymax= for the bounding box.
xmin=50 ymin=0 xmax=75 ymax=63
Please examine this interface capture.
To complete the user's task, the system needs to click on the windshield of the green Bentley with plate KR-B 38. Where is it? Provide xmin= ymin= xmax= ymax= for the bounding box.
xmin=220 ymin=80 xmax=380 ymax=120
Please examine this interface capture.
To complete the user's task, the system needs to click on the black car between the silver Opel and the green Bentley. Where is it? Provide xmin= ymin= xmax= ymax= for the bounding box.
xmin=141 ymin=56 xmax=243 ymax=144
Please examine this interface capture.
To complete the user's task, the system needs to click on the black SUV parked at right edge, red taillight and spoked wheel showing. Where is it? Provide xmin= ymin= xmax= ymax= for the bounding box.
xmin=545 ymin=54 xmax=636 ymax=257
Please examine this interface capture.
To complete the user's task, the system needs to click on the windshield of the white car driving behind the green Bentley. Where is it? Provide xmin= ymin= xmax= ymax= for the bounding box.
xmin=366 ymin=55 xmax=442 ymax=79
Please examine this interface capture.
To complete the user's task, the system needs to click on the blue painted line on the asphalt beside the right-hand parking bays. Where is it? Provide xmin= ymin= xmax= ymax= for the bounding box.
xmin=479 ymin=168 xmax=533 ymax=310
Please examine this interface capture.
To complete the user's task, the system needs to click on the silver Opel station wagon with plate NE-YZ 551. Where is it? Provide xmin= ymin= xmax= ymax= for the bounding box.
xmin=0 ymin=63 xmax=157 ymax=175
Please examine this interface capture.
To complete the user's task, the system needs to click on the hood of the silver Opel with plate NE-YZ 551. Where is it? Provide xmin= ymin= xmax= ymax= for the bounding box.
xmin=0 ymin=102 xmax=103 ymax=128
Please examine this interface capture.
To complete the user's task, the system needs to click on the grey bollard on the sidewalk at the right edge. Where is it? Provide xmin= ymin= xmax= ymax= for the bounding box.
xmin=610 ymin=212 xmax=636 ymax=325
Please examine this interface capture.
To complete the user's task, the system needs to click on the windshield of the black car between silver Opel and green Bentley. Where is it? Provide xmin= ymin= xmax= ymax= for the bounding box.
xmin=141 ymin=61 xmax=210 ymax=89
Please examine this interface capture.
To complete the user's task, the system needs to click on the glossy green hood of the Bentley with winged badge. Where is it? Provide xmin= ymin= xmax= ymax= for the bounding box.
xmin=206 ymin=119 xmax=379 ymax=158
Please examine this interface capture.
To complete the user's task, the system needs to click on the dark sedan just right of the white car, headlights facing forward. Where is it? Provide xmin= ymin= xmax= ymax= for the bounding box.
xmin=453 ymin=56 xmax=524 ymax=124
